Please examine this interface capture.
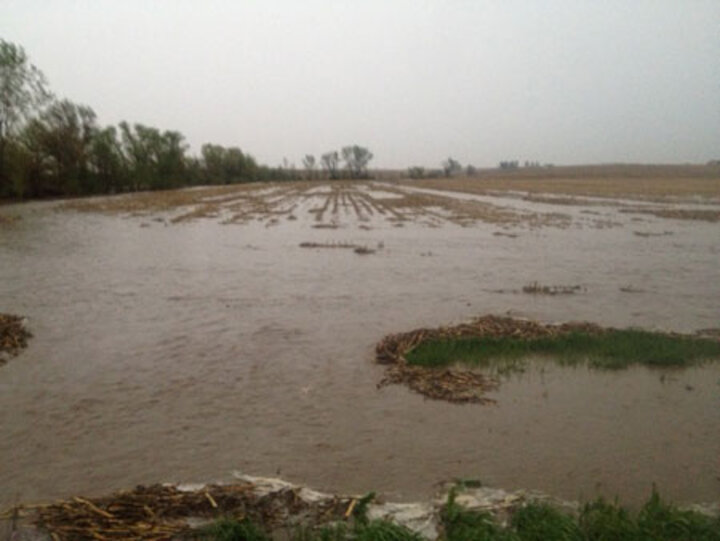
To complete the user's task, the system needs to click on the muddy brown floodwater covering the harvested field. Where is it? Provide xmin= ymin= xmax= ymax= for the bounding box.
xmin=0 ymin=185 xmax=720 ymax=507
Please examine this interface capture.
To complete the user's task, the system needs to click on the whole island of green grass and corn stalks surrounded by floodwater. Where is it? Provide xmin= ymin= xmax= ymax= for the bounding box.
xmin=376 ymin=315 xmax=720 ymax=403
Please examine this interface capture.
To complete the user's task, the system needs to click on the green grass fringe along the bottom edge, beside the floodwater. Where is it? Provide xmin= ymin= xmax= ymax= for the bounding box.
xmin=190 ymin=491 xmax=720 ymax=541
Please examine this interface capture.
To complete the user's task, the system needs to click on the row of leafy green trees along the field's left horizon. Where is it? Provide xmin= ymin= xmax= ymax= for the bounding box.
xmin=0 ymin=39 xmax=373 ymax=198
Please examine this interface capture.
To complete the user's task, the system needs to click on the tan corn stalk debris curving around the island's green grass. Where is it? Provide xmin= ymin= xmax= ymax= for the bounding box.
xmin=375 ymin=315 xmax=603 ymax=404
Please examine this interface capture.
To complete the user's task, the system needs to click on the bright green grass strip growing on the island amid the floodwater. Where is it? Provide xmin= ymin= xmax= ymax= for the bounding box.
xmin=405 ymin=329 xmax=720 ymax=369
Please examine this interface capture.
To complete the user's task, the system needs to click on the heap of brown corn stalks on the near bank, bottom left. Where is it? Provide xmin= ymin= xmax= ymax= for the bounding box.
xmin=24 ymin=483 xmax=352 ymax=541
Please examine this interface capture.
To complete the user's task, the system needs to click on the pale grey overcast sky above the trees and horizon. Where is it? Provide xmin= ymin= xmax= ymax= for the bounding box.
xmin=0 ymin=0 xmax=720 ymax=168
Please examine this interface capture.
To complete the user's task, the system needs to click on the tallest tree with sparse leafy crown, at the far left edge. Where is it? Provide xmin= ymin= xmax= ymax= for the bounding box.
xmin=0 ymin=39 xmax=50 ymax=194
